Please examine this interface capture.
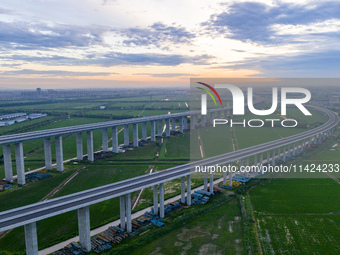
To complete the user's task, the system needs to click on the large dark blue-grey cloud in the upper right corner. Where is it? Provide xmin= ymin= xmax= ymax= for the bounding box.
xmin=202 ymin=2 xmax=340 ymax=44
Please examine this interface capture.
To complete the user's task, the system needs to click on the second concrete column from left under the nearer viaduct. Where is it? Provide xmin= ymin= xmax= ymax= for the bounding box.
xmin=78 ymin=206 xmax=91 ymax=252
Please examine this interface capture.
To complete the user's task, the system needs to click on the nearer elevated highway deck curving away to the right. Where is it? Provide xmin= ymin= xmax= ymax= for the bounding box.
xmin=0 ymin=104 xmax=339 ymax=231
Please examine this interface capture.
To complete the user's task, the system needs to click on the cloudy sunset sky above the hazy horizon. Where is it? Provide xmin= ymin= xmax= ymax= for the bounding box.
xmin=0 ymin=0 xmax=340 ymax=90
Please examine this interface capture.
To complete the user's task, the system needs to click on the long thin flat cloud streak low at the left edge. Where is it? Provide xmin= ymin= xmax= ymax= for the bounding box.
xmin=0 ymin=69 xmax=118 ymax=77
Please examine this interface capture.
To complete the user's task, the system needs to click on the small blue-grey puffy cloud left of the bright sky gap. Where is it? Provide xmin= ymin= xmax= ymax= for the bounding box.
xmin=120 ymin=22 xmax=196 ymax=47
